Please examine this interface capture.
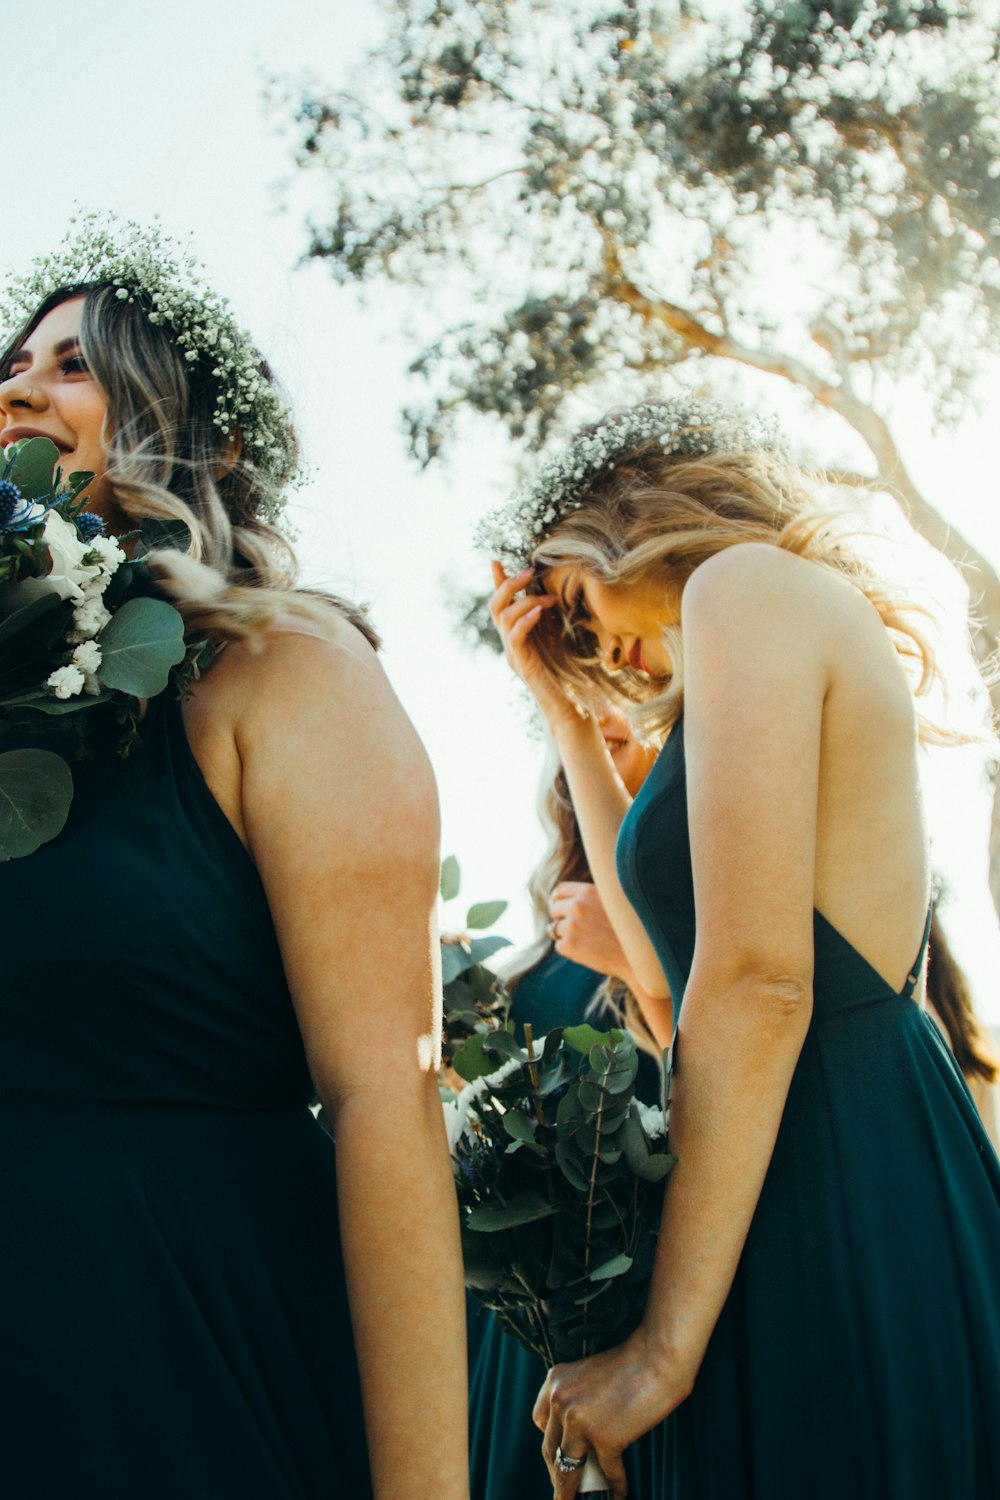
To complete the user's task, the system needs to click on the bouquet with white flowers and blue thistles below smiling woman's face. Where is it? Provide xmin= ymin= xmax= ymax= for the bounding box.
xmin=0 ymin=438 xmax=193 ymax=860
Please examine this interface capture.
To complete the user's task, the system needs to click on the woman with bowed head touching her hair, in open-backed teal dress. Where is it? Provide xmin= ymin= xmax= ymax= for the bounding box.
xmin=486 ymin=398 xmax=1000 ymax=1500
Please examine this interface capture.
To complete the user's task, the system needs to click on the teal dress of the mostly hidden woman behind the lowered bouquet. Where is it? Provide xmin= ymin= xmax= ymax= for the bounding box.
xmin=466 ymin=950 xmax=660 ymax=1500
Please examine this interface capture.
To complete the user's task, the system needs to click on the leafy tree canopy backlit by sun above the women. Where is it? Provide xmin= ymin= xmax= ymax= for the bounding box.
xmin=284 ymin=0 xmax=1000 ymax=464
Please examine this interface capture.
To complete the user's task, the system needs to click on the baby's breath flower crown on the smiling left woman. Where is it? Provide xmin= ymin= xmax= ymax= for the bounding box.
xmin=0 ymin=213 xmax=298 ymax=504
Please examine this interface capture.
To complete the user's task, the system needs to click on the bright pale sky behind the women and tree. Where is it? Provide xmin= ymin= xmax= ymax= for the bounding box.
xmin=7 ymin=0 xmax=1000 ymax=1022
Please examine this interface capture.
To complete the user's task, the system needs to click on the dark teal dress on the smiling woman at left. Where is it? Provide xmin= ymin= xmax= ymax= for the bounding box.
xmin=0 ymin=695 xmax=370 ymax=1500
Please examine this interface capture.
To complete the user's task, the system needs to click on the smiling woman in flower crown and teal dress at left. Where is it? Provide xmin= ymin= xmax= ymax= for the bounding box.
xmin=0 ymin=222 xmax=468 ymax=1500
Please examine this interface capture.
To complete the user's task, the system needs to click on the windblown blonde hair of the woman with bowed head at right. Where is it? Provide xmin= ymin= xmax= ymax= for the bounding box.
xmin=532 ymin=441 xmax=967 ymax=744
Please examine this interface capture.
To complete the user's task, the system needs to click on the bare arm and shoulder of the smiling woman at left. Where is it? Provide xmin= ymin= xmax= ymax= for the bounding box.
xmin=237 ymin=627 xmax=468 ymax=1500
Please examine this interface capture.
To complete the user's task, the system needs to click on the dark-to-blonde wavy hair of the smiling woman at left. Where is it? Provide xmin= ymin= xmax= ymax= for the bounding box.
xmin=0 ymin=284 xmax=379 ymax=647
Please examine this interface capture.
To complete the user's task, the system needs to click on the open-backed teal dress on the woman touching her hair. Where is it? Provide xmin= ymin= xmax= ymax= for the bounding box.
xmin=618 ymin=723 xmax=1000 ymax=1500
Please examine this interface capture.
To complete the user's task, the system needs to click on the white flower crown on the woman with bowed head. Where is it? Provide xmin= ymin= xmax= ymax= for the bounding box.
xmin=475 ymin=395 xmax=784 ymax=573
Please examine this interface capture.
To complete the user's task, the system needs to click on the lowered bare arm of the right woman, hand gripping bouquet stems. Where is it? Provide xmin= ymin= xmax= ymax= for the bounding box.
xmin=535 ymin=548 xmax=832 ymax=1497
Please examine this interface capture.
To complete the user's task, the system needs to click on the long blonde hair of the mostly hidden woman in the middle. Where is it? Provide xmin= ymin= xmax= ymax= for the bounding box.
xmin=501 ymin=761 xmax=661 ymax=1062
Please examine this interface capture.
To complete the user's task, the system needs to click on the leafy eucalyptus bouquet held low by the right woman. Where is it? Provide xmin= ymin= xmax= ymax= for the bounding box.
xmin=445 ymin=1023 xmax=675 ymax=1493
